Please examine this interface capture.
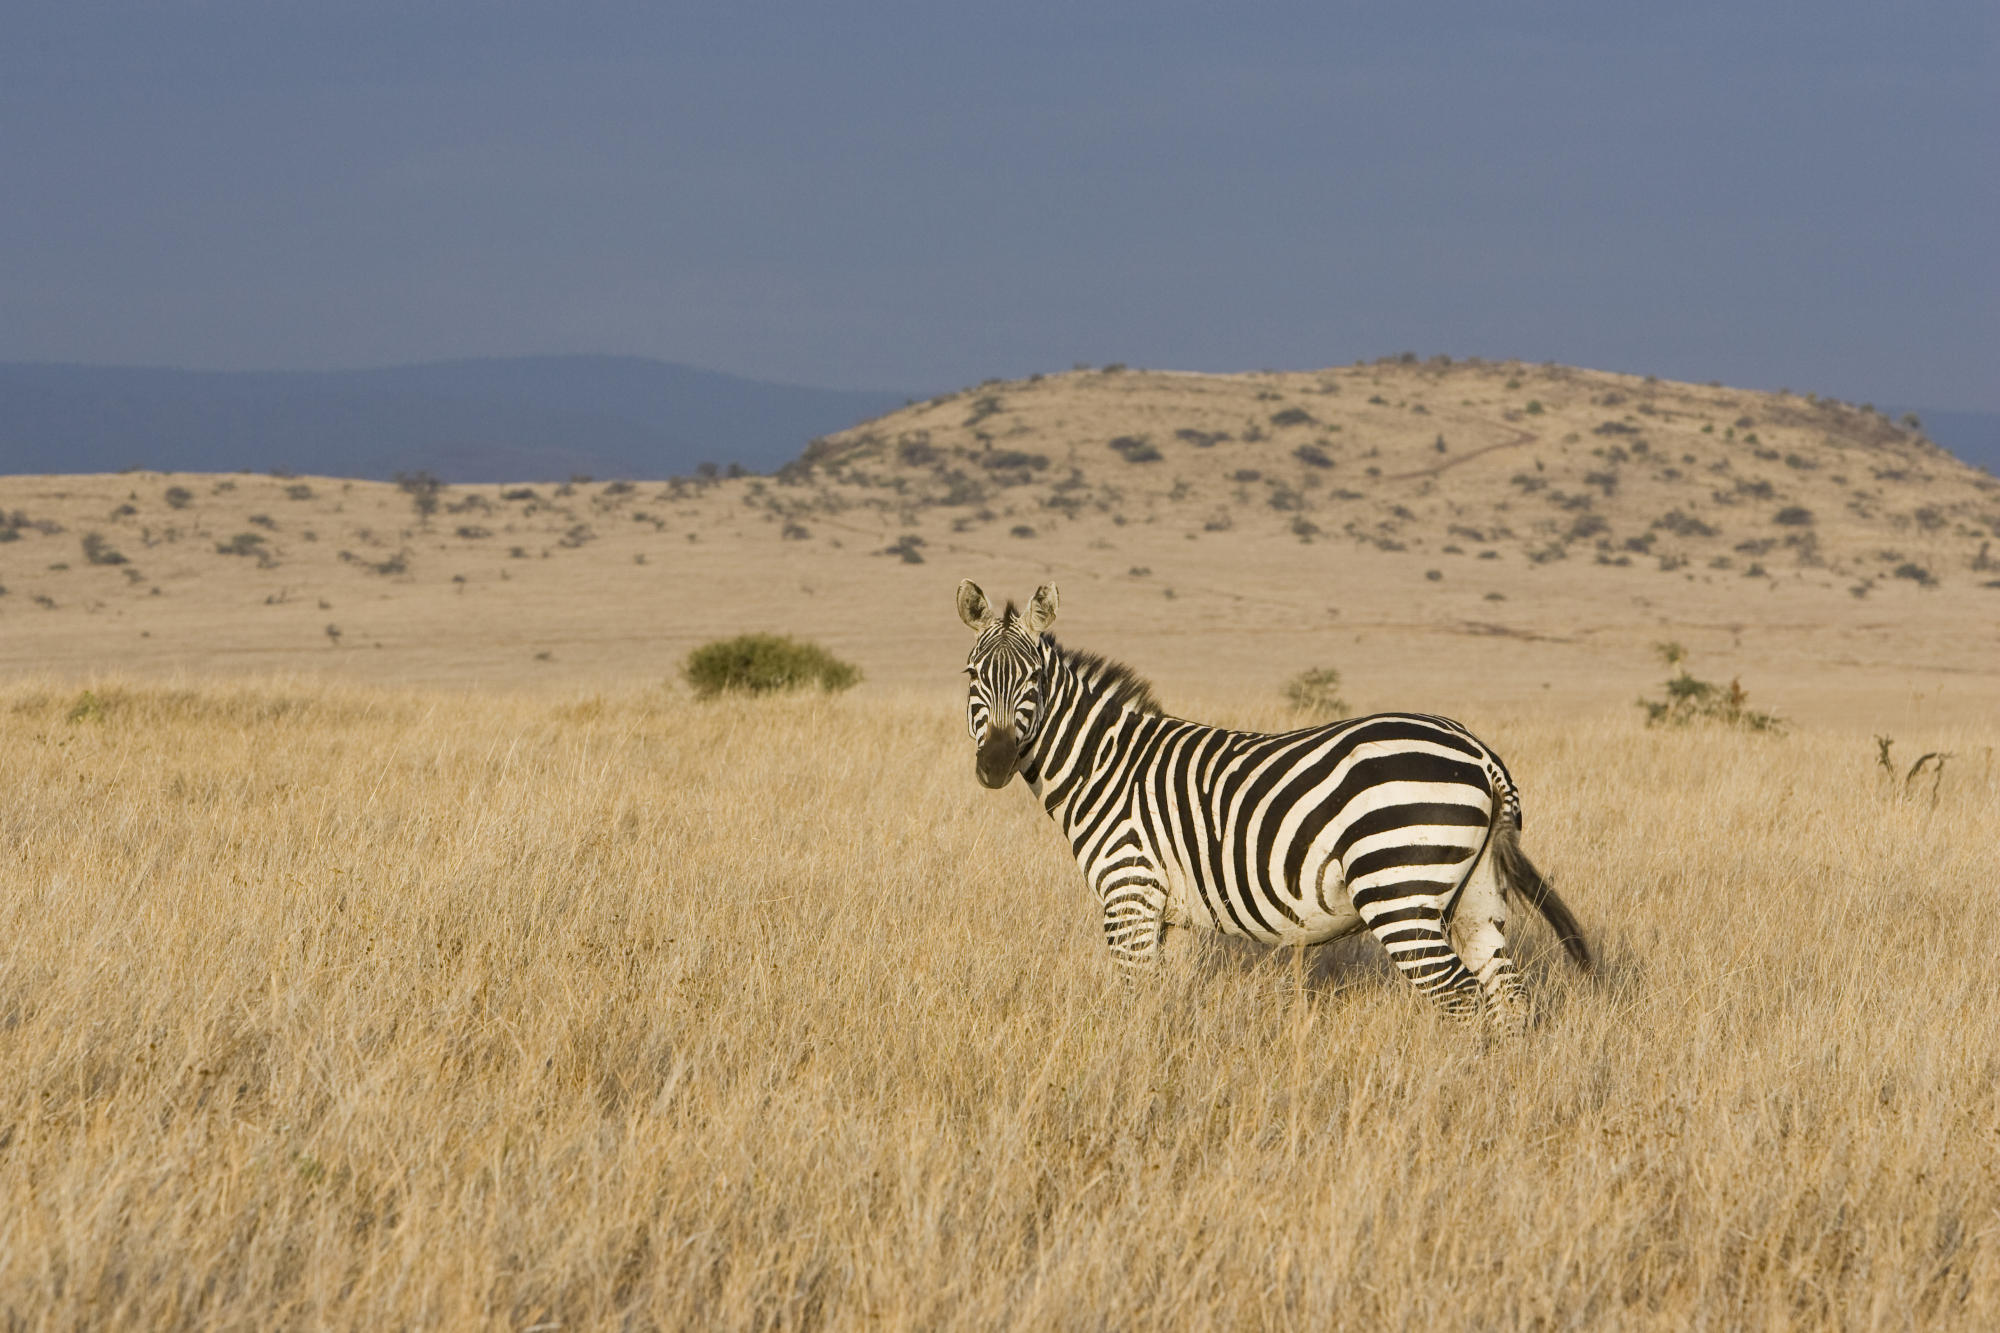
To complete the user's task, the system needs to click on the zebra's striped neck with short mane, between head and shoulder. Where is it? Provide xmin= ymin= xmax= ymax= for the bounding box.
xmin=1022 ymin=636 xmax=1162 ymax=825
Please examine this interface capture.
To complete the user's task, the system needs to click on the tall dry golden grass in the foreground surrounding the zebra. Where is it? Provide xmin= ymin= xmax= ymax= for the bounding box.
xmin=0 ymin=681 xmax=2000 ymax=1329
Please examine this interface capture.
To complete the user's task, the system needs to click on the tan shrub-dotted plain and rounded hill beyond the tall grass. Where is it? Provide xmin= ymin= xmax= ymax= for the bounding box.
xmin=0 ymin=360 xmax=2000 ymax=719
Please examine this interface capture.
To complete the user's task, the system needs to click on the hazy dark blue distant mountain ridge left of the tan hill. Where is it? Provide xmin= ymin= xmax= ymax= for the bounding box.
xmin=0 ymin=356 xmax=906 ymax=482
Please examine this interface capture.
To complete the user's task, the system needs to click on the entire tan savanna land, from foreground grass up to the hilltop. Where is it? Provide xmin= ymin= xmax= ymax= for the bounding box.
xmin=0 ymin=358 xmax=2000 ymax=1333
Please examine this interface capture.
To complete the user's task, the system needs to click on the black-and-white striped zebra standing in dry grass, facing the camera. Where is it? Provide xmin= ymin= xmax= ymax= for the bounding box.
xmin=958 ymin=578 xmax=1590 ymax=1031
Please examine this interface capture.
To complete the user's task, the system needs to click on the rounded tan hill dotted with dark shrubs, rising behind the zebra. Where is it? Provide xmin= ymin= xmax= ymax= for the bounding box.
xmin=794 ymin=358 xmax=2000 ymax=584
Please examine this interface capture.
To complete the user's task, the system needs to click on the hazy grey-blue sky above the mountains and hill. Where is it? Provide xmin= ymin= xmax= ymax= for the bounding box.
xmin=0 ymin=0 xmax=2000 ymax=408
